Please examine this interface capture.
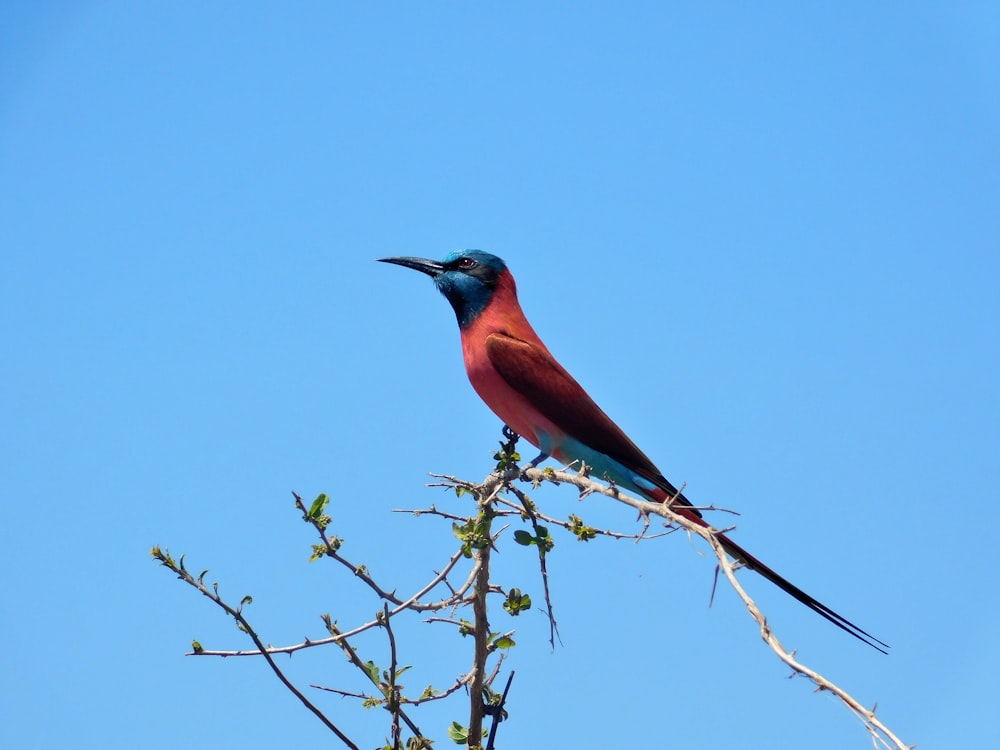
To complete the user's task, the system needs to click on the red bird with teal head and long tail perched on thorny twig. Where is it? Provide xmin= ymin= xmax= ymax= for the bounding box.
xmin=379 ymin=250 xmax=889 ymax=654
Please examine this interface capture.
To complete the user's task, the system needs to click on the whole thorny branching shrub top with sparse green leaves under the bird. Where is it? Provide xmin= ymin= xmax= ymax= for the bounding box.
xmin=153 ymin=433 xmax=910 ymax=750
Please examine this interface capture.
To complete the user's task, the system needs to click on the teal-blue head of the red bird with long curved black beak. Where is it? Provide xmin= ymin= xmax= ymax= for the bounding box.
xmin=379 ymin=250 xmax=507 ymax=328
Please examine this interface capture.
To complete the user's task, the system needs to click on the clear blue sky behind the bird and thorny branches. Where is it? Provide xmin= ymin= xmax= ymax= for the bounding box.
xmin=0 ymin=2 xmax=1000 ymax=750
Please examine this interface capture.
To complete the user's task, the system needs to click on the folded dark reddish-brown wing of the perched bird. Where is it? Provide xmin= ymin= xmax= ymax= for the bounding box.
xmin=486 ymin=333 xmax=687 ymax=504
